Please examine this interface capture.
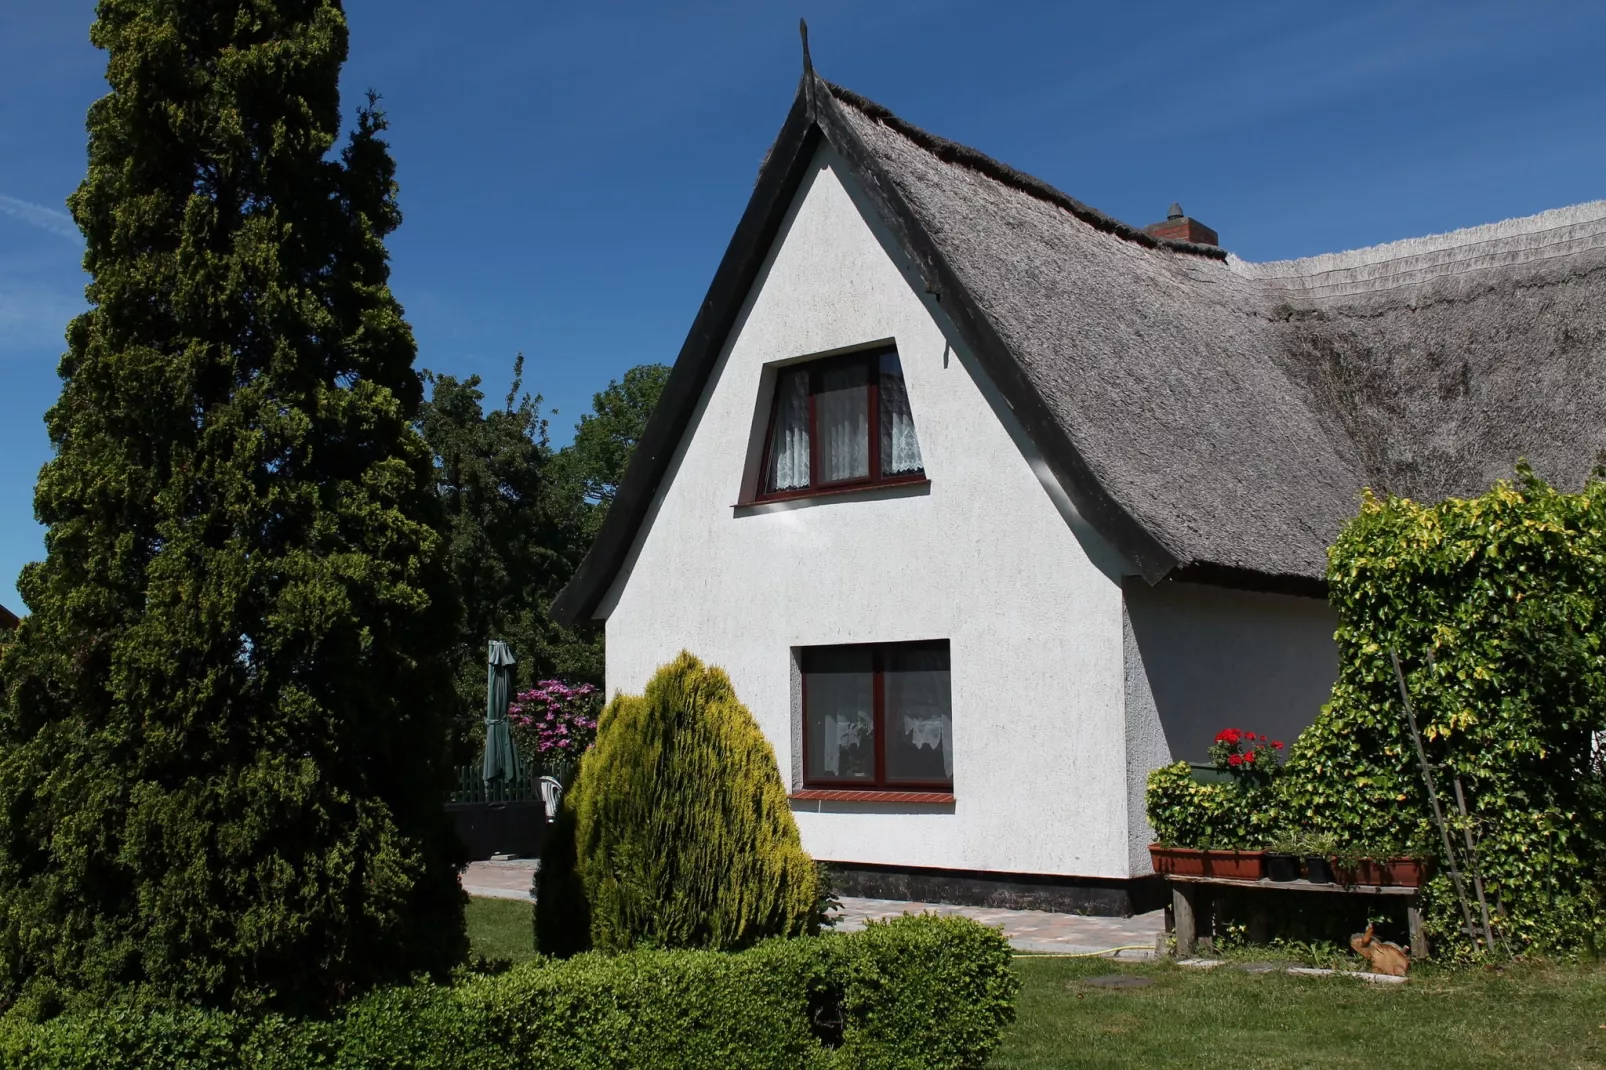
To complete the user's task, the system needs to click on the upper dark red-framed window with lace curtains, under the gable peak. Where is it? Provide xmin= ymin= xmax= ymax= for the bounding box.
xmin=760 ymin=349 xmax=925 ymax=498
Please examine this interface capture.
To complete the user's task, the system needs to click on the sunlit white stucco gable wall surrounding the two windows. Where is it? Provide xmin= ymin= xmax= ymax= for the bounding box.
xmin=601 ymin=148 xmax=1132 ymax=877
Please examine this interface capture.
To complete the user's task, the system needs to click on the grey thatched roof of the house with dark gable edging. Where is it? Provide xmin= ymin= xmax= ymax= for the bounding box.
xmin=554 ymin=72 xmax=1606 ymax=620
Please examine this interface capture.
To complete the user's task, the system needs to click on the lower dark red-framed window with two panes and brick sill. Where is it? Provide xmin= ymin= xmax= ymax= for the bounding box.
xmin=801 ymin=639 xmax=954 ymax=789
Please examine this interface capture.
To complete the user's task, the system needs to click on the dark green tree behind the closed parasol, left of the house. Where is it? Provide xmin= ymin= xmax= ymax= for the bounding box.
xmin=418 ymin=353 xmax=602 ymax=742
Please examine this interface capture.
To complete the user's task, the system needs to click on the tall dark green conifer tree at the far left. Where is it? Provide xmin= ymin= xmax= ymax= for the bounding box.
xmin=0 ymin=0 xmax=464 ymax=1011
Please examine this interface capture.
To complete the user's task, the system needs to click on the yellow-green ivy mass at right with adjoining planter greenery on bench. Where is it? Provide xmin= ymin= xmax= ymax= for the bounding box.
xmin=1150 ymin=468 xmax=1606 ymax=951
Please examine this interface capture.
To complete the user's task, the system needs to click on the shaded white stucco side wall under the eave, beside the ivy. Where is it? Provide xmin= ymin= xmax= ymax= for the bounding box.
xmin=1124 ymin=578 xmax=1338 ymax=872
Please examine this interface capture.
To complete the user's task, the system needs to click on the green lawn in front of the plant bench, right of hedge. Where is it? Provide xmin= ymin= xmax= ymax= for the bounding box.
xmin=993 ymin=958 xmax=1606 ymax=1070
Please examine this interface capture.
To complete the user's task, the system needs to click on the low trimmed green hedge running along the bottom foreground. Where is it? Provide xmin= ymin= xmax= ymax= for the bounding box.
xmin=0 ymin=917 xmax=1018 ymax=1070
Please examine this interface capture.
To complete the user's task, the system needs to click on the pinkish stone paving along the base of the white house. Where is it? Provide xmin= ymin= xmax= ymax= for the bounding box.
xmin=463 ymin=858 xmax=1166 ymax=959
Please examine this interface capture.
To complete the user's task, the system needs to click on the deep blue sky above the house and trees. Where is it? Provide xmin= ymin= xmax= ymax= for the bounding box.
xmin=0 ymin=0 xmax=1606 ymax=611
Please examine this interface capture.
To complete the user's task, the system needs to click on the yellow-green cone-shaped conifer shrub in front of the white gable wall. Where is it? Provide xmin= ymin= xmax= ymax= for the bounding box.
xmin=536 ymin=652 xmax=816 ymax=954
